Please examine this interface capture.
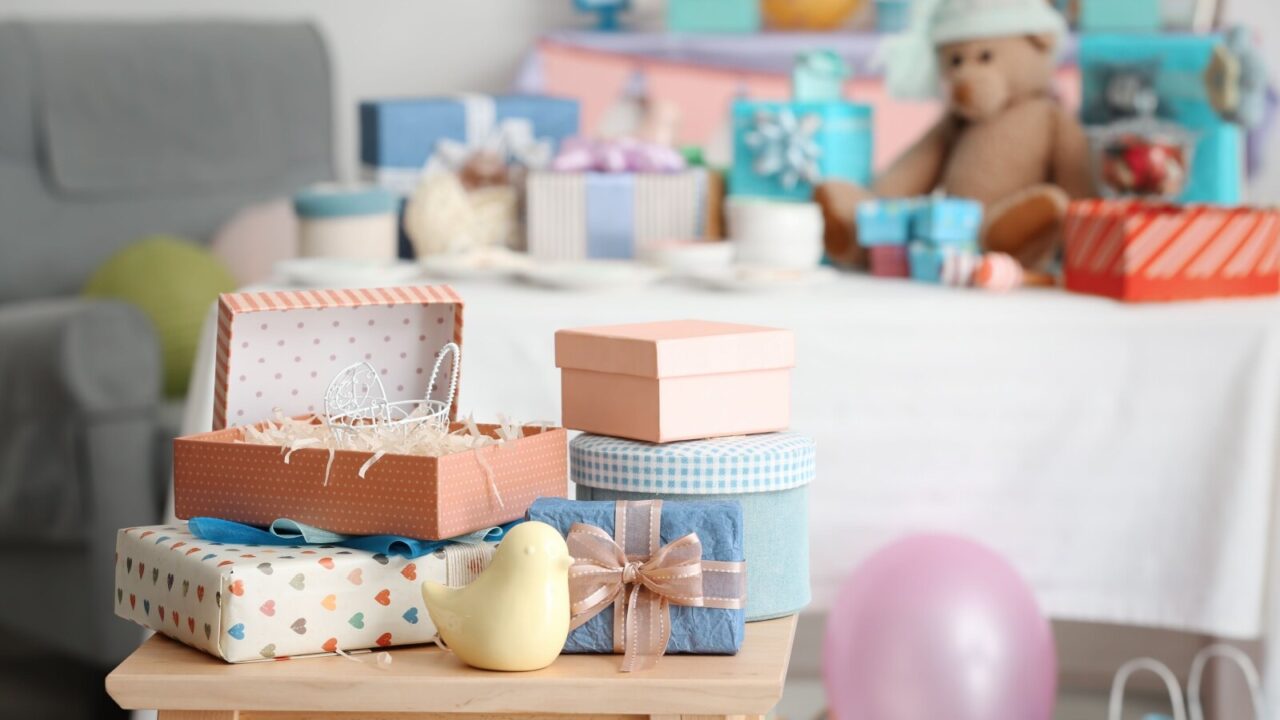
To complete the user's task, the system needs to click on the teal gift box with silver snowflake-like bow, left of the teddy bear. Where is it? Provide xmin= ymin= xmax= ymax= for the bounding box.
xmin=728 ymin=100 xmax=872 ymax=200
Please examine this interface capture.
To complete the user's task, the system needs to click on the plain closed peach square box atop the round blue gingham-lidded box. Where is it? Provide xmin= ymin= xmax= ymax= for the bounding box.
xmin=556 ymin=320 xmax=795 ymax=443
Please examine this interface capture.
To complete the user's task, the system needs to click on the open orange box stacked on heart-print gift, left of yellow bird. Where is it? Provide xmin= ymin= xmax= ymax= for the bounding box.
xmin=113 ymin=287 xmax=567 ymax=662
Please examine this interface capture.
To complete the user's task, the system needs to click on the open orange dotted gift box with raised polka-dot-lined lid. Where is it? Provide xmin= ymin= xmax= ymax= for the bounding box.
xmin=174 ymin=287 xmax=568 ymax=539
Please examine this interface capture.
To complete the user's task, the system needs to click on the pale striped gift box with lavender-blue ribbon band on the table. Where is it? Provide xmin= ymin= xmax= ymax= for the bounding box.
xmin=526 ymin=169 xmax=707 ymax=260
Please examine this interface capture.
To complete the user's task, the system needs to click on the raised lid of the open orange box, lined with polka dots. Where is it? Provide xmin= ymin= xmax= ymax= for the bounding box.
xmin=212 ymin=286 xmax=462 ymax=430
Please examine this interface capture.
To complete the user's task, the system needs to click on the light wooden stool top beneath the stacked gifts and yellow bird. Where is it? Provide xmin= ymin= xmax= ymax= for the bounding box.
xmin=106 ymin=616 xmax=796 ymax=720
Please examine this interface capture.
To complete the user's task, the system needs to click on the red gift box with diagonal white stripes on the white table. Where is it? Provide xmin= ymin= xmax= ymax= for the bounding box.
xmin=1065 ymin=200 xmax=1280 ymax=301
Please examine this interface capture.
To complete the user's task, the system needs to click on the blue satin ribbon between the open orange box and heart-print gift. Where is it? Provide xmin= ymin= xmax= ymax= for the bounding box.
xmin=187 ymin=518 xmax=520 ymax=559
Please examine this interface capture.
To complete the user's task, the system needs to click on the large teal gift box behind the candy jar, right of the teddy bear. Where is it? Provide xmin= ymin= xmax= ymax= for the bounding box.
xmin=1079 ymin=35 xmax=1244 ymax=205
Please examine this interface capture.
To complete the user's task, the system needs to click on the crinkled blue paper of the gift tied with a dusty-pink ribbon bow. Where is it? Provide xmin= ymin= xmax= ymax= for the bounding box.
xmin=527 ymin=498 xmax=750 ymax=655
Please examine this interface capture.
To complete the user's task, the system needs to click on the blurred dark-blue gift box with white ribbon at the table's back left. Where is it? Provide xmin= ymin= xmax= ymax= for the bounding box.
xmin=360 ymin=95 xmax=579 ymax=193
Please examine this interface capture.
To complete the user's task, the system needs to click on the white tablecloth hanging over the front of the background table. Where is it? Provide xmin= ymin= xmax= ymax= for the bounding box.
xmin=180 ymin=277 xmax=1280 ymax=637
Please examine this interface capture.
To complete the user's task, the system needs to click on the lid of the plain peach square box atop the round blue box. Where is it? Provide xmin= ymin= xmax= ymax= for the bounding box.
xmin=556 ymin=320 xmax=795 ymax=378
